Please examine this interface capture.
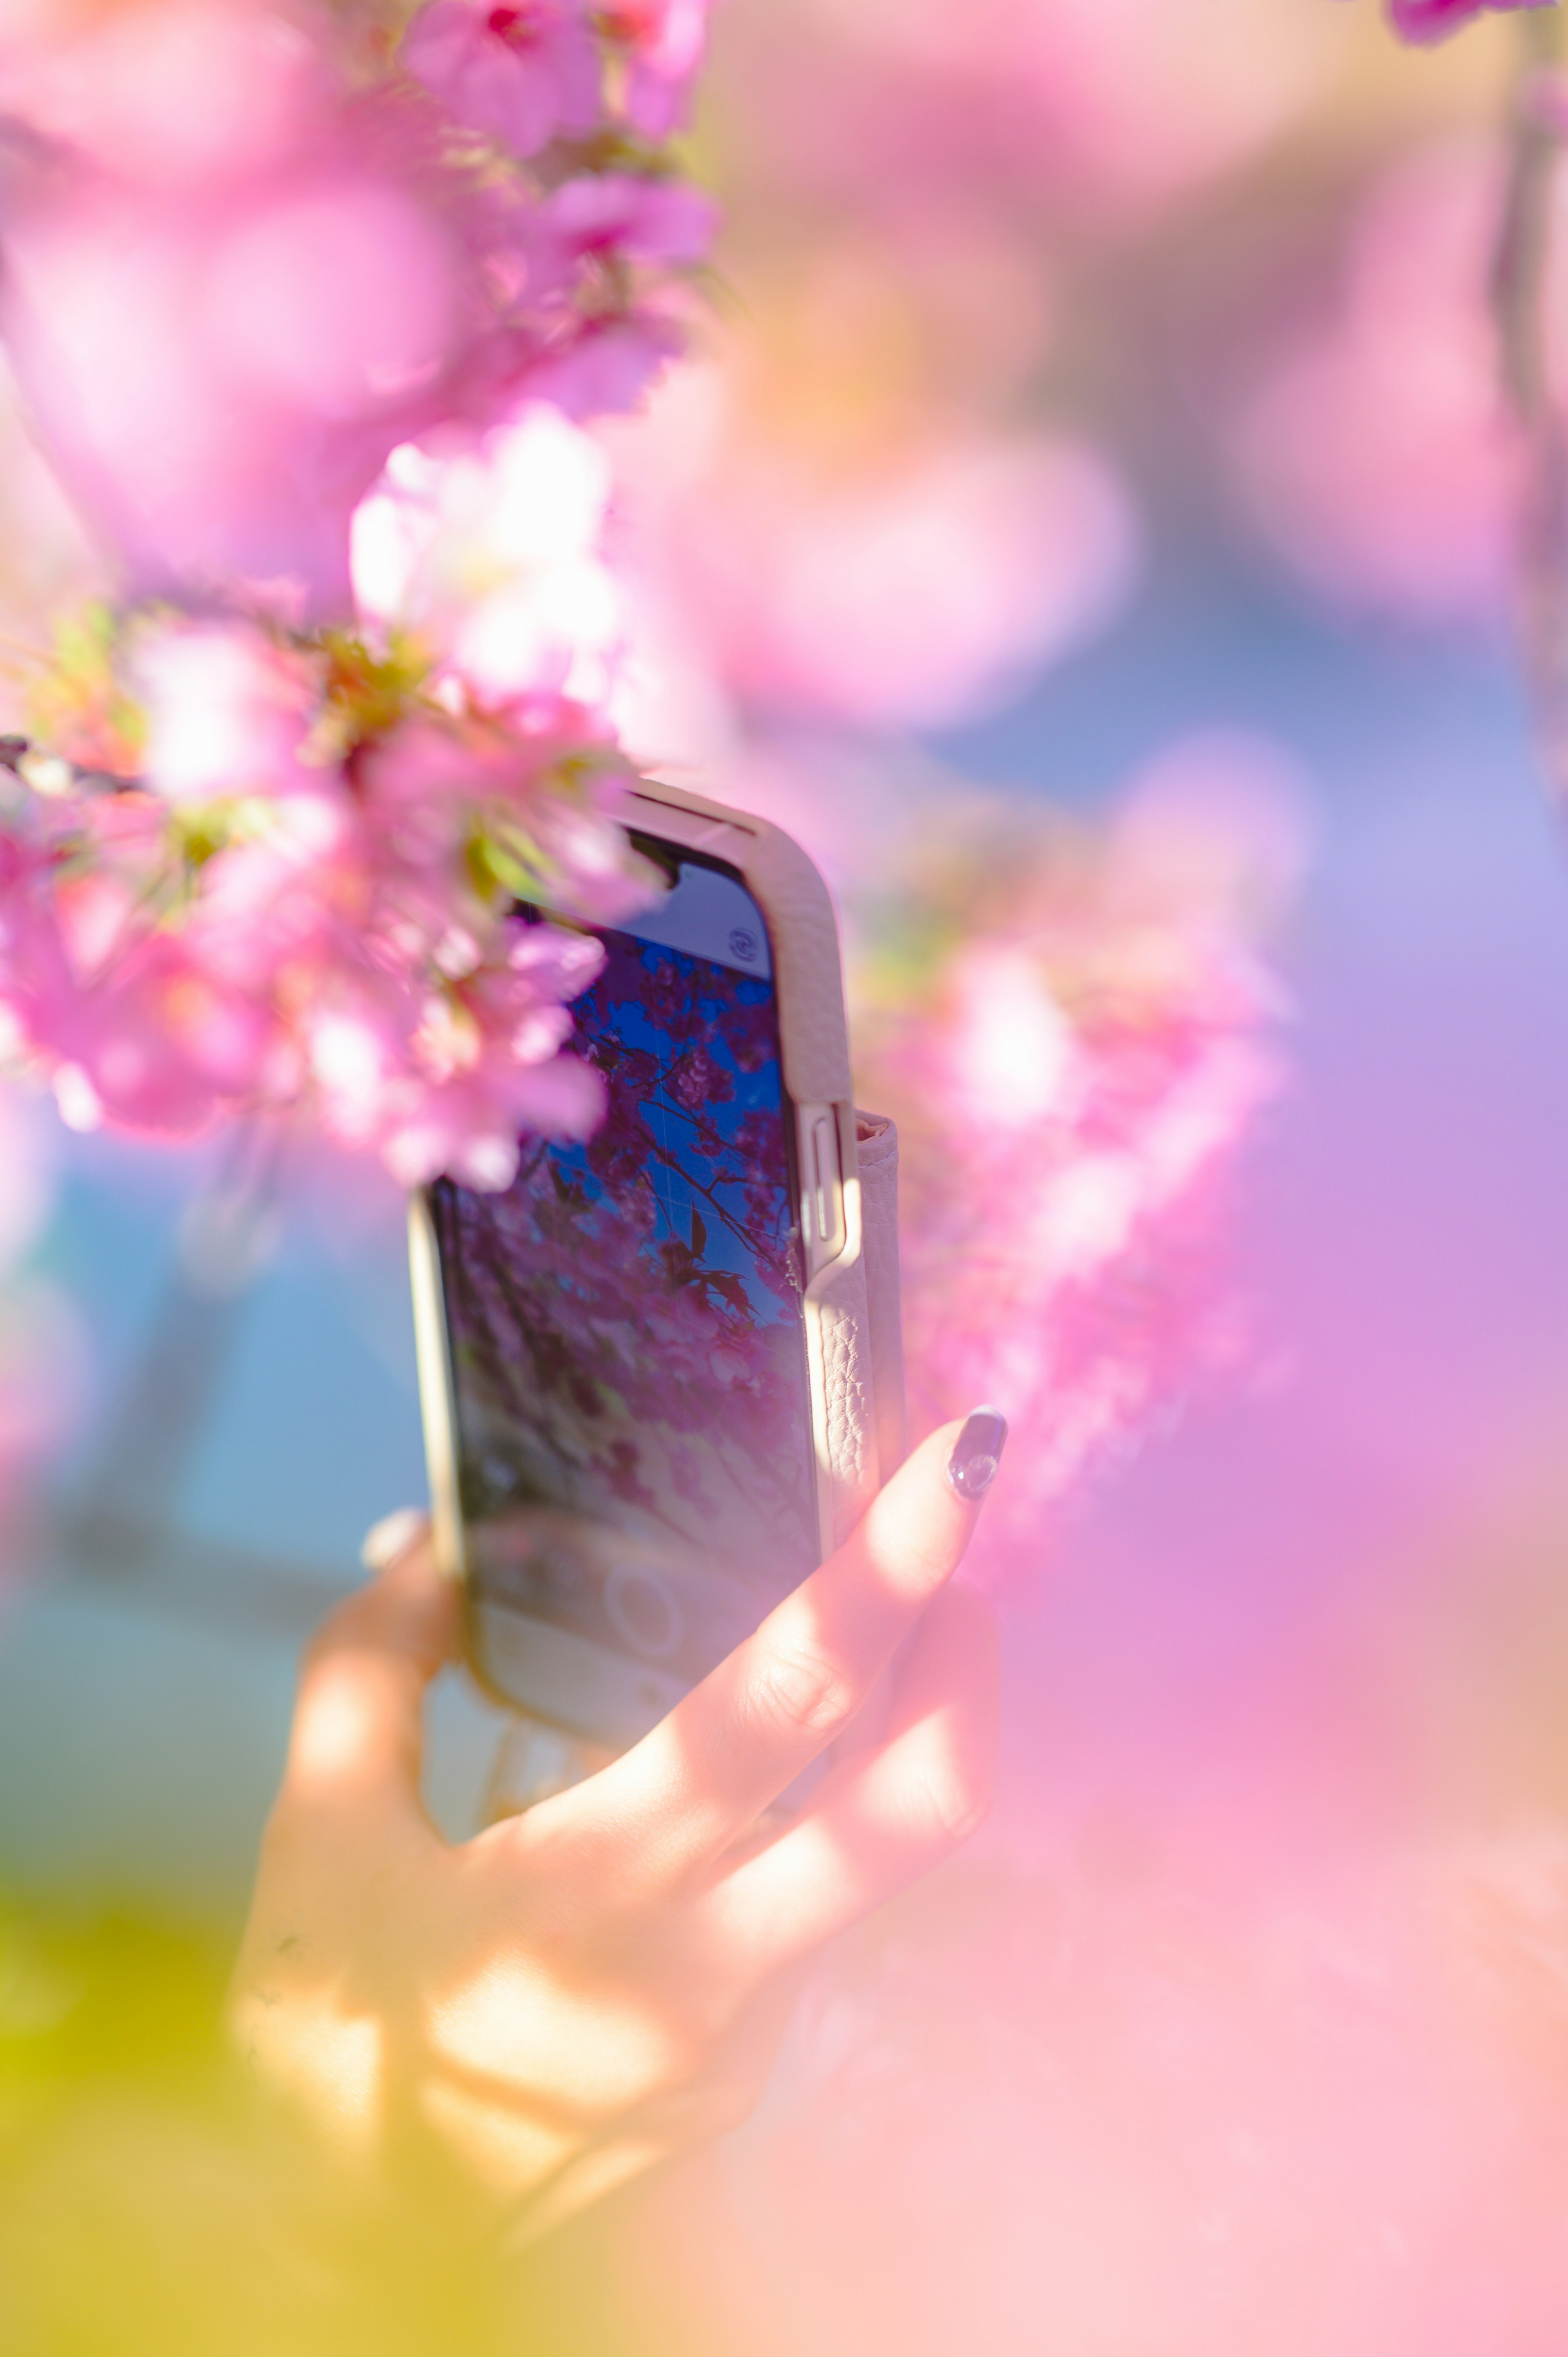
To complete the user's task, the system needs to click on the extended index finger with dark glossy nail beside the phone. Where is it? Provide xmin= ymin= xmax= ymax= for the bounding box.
xmin=575 ymin=1409 xmax=1004 ymax=1874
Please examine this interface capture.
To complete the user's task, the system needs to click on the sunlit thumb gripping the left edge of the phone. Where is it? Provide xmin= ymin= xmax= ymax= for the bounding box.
xmin=283 ymin=1516 xmax=457 ymax=1808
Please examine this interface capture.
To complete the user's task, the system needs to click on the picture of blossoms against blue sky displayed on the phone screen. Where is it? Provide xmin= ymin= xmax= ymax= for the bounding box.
xmin=436 ymin=910 xmax=816 ymax=1676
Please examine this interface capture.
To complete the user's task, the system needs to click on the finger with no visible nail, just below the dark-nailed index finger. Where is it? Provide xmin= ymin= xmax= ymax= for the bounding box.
xmin=703 ymin=1589 xmax=998 ymax=1980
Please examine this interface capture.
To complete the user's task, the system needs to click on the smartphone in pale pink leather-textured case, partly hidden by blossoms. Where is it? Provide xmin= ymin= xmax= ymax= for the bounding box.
xmin=410 ymin=787 xmax=875 ymax=1749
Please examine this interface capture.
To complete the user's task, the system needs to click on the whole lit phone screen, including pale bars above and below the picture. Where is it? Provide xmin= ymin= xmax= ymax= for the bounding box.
xmin=432 ymin=846 xmax=818 ymax=1742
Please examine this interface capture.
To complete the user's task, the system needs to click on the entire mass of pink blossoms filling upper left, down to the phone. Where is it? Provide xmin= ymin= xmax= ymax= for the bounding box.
xmin=0 ymin=0 xmax=715 ymax=1188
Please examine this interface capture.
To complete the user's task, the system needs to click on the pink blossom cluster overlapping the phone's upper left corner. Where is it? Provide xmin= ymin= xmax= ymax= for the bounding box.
xmin=0 ymin=618 xmax=653 ymax=1186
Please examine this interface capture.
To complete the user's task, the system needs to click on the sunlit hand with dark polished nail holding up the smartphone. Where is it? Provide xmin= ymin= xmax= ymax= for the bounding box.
xmin=231 ymin=1419 xmax=1004 ymax=2230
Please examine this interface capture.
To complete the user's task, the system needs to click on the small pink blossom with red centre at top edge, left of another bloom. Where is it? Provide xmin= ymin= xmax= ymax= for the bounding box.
xmin=403 ymin=0 xmax=601 ymax=156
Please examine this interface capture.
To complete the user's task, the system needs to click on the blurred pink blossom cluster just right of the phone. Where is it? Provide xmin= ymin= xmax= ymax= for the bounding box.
xmin=856 ymin=738 xmax=1301 ymax=1530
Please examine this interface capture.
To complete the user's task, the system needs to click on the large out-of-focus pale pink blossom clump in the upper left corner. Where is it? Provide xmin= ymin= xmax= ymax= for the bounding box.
xmin=0 ymin=0 xmax=712 ymax=622
